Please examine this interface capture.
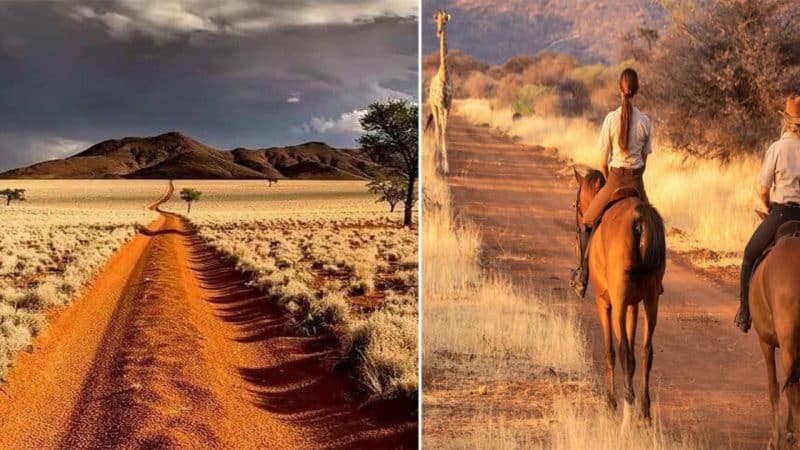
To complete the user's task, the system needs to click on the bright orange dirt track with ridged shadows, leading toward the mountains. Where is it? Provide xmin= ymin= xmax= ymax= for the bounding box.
xmin=0 ymin=183 xmax=417 ymax=449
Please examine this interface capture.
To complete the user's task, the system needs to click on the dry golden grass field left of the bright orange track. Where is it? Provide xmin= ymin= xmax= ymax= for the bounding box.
xmin=0 ymin=180 xmax=164 ymax=380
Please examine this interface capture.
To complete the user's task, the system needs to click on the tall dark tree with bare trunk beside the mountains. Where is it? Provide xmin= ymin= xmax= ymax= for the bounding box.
xmin=357 ymin=99 xmax=419 ymax=227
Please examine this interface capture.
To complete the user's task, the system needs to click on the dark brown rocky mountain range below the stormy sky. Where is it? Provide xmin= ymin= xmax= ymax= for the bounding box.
xmin=0 ymin=132 xmax=377 ymax=180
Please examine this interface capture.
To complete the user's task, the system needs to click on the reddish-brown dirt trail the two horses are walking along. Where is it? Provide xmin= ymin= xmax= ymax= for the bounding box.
xmin=448 ymin=116 xmax=772 ymax=449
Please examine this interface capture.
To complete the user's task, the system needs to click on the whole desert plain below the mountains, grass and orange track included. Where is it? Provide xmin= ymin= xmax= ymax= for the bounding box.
xmin=0 ymin=180 xmax=418 ymax=448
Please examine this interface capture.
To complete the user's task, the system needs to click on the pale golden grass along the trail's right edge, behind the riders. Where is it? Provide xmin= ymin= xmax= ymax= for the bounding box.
xmin=455 ymin=99 xmax=764 ymax=266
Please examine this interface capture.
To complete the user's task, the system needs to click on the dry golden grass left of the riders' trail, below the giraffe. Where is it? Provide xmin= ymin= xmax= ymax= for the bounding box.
xmin=422 ymin=128 xmax=589 ymax=448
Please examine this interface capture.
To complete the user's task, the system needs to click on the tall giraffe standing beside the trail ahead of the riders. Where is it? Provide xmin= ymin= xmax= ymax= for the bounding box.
xmin=425 ymin=9 xmax=453 ymax=175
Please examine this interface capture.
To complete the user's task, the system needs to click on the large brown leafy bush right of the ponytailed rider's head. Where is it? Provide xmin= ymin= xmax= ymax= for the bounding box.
xmin=646 ymin=0 xmax=800 ymax=159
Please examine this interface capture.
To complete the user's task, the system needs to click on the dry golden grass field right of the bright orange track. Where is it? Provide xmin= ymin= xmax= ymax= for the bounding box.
xmin=164 ymin=180 xmax=418 ymax=399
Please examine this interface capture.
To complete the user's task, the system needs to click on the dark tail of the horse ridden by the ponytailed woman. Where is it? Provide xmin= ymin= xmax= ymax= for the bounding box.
xmin=628 ymin=203 xmax=667 ymax=279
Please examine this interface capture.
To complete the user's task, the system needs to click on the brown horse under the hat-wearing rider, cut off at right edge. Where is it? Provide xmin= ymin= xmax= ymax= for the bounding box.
xmin=750 ymin=213 xmax=800 ymax=449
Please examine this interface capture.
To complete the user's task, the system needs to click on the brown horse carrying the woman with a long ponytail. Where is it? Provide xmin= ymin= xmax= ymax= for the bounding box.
xmin=575 ymin=168 xmax=666 ymax=428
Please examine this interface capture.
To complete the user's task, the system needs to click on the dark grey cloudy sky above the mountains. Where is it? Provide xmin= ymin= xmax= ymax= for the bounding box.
xmin=0 ymin=0 xmax=417 ymax=170
